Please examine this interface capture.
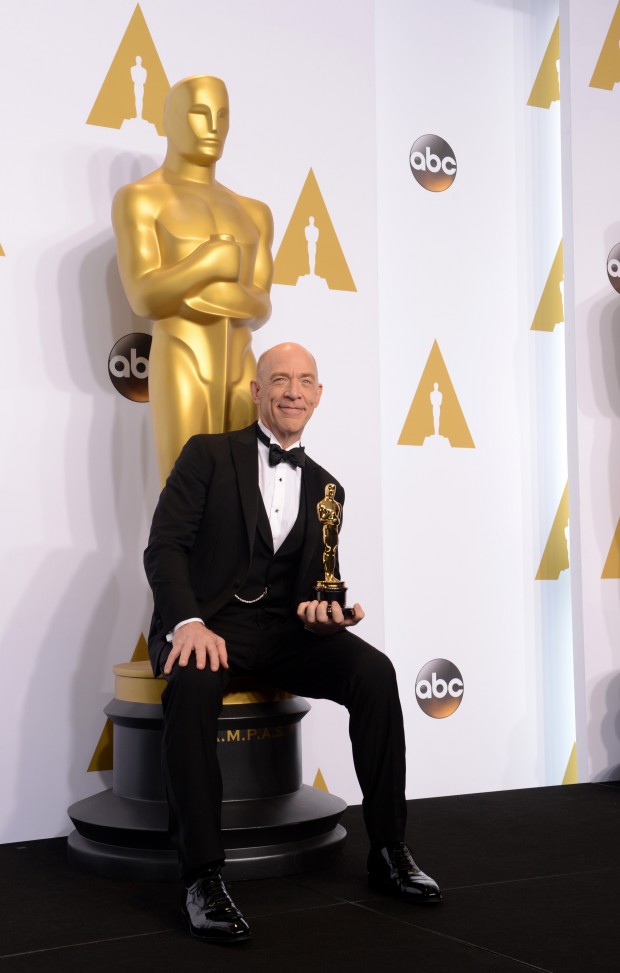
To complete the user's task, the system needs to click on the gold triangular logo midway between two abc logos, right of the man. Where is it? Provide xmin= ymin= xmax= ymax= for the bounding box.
xmin=398 ymin=341 xmax=475 ymax=449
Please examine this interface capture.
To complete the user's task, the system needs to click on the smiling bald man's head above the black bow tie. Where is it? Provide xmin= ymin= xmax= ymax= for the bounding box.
xmin=250 ymin=344 xmax=323 ymax=449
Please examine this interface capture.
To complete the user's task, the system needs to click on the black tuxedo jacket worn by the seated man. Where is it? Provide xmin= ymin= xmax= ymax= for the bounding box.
xmin=144 ymin=423 xmax=344 ymax=673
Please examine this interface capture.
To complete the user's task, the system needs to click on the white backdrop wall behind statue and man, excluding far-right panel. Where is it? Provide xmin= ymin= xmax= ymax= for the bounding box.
xmin=0 ymin=0 xmax=604 ymax=841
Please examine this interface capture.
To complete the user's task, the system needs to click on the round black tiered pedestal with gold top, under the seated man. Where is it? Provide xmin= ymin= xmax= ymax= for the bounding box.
xmin=68 ymin=662 xmax=346 ymax=881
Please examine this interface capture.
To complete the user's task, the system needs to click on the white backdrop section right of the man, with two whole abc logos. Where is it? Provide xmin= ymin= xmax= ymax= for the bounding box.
xmin=377 ymin=0 xmax=574 ymax=794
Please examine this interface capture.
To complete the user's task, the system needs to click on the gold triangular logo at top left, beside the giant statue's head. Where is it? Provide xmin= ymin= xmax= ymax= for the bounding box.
xmin=86 ymin=4 xmax=170 ymax=135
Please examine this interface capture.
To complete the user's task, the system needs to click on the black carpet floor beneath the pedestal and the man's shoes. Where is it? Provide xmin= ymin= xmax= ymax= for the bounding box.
xmin=0 ymin=784 xmax=620 ymax=973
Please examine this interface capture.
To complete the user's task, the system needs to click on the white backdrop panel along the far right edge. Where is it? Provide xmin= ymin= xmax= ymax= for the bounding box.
xmin=562 ymin=0 xmax=620 ymax=780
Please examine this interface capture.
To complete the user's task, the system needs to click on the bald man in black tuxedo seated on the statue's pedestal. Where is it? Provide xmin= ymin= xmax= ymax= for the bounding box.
xmin=144 ymin=343 xmax=441 ymax=943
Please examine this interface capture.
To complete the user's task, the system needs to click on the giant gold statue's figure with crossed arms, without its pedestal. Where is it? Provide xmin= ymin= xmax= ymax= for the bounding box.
xmin=112 ymin=77 xmax=273 ymax=483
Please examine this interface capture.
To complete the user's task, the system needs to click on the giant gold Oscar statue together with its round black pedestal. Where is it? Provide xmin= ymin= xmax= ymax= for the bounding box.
xmin=63 ymin=77 xmax=346 ymax=881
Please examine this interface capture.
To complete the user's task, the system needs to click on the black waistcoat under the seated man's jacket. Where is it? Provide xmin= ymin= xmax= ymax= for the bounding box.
xmin=237 ymin=484 xmax=306 ymax=614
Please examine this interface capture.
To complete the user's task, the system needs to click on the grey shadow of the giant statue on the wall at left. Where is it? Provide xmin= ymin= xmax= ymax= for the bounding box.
xmin=5 ymin=151 xmax=158 ymax=840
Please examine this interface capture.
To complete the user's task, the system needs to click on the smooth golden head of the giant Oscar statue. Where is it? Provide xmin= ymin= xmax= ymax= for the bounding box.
xmin=164 ymin=77 xmax=229 ymax=166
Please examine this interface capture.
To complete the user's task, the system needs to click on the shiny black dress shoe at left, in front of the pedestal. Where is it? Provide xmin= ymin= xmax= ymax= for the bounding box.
xmin=182 ymin=871 xmax=251 ymax=943
